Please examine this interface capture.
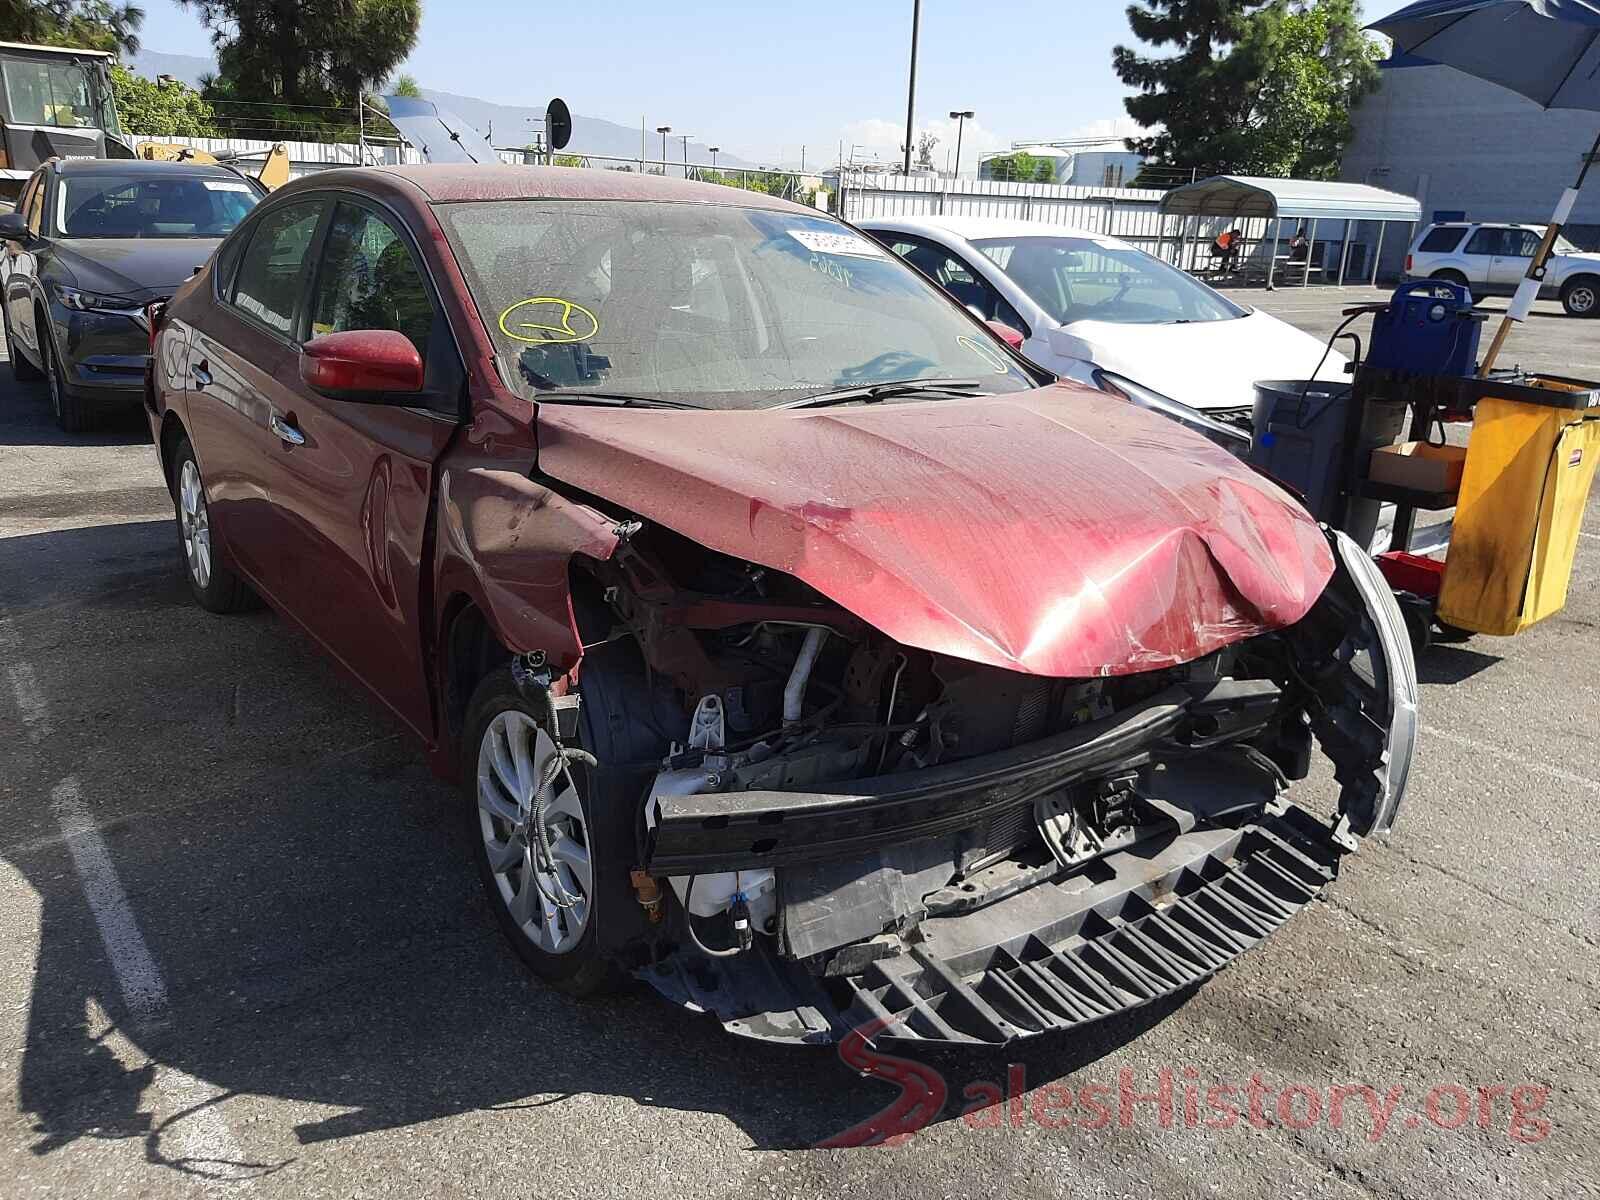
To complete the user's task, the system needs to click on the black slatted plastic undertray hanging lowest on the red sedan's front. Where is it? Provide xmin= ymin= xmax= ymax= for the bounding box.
xmin=640 ymin=805 xmax=1341 ymax=1045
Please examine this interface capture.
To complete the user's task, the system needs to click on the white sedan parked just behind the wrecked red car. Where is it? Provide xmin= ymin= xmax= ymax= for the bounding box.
xmin=856 ymin=216 xmax=1346 ymax=451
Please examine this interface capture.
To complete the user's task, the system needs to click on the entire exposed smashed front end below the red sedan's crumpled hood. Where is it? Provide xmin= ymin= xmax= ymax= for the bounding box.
xmin=556 ymin=522 xmax=1416 ymax=1042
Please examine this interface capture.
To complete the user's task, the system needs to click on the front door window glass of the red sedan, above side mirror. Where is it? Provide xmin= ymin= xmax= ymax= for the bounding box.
xmin=310 ymin=202 xmax=434 ymax=362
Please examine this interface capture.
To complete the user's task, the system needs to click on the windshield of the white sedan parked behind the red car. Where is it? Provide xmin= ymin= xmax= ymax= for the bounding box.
xmin=973 ymin=237 xmax=1246 ymax=325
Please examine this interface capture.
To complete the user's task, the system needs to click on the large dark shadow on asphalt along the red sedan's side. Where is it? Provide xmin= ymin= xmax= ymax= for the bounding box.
xmin=0 ymin=522 xmax=1203 ymax=1179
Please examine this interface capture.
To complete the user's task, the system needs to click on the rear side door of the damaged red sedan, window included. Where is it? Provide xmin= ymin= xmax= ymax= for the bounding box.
xmin=187 ymin=197 xmax=330 ymax=588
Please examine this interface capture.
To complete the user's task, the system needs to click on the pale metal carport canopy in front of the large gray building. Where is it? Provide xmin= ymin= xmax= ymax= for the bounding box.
xmin=1162 ymin=174 xmax=1422 ymax=288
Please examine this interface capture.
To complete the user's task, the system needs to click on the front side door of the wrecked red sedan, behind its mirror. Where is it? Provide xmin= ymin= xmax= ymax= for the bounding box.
xmin=248 ymin=202 xmax=466 ymax=738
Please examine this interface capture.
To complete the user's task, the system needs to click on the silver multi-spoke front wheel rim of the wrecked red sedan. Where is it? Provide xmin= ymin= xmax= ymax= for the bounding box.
xmin=477 ymin=709 xmax=594 ymax=955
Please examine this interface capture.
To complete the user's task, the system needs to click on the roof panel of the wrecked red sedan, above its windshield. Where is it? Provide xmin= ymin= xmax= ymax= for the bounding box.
xmin=285 ymin=163 xmax=812 ymax=218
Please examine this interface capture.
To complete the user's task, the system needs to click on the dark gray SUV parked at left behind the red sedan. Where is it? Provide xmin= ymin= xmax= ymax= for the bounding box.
xmin=0 ymin=158 xmax=264 ymax=432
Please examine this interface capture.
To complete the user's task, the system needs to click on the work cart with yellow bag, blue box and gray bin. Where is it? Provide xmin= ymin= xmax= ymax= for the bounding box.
xmin=1251 ymin=280 xmax=1600 ymax=651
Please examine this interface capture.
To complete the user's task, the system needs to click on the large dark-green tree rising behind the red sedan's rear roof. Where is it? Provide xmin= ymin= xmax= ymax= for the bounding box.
xmin=179 ymin=0 xmax=422 ymax=138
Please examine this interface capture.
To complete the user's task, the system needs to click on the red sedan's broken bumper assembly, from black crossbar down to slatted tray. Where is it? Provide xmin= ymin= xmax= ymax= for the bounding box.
xmin=637 ymin=533 xmax=1418 ymax=1045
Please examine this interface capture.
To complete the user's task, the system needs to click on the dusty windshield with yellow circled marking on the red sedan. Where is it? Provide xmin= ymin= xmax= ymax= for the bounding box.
xmin=437 ymin=200 xmax=1035 ymax=408
